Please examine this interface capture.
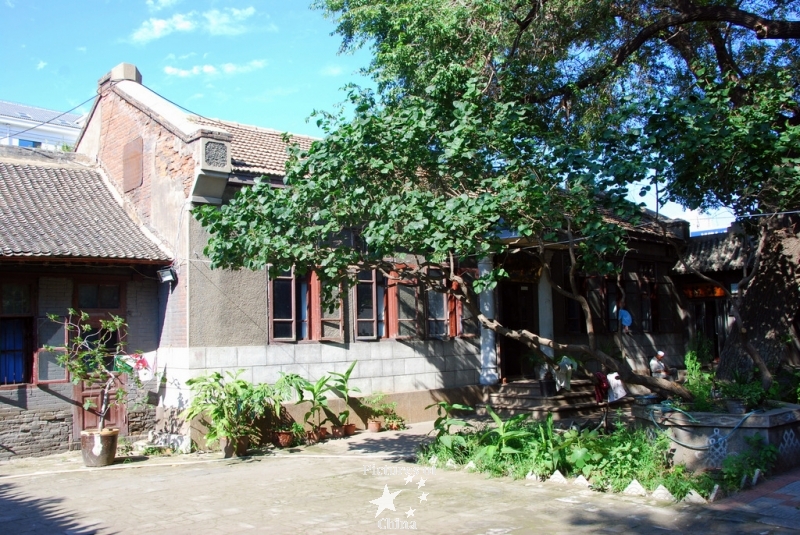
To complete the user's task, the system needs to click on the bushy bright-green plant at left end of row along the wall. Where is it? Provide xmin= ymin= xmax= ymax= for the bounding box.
xmin=181 ymin=370 xmax=272 ymax=458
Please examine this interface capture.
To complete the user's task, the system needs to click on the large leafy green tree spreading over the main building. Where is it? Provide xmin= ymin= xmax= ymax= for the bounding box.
xmin=196 ymin=0 xmax=800 ymax=396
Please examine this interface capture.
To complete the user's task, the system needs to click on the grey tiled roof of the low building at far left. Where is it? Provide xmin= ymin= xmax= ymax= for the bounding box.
xmin=0 ymin=161 xmax=170 ymax=263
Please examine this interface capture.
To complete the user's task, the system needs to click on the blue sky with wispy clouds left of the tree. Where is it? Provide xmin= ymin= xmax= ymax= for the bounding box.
xmin=0 ymin=0 xmax=369 ymax=135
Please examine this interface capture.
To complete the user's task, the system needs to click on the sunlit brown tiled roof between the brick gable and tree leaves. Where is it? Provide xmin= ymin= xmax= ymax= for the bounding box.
xmin=191 ymin=116 xmax=316 ymax=176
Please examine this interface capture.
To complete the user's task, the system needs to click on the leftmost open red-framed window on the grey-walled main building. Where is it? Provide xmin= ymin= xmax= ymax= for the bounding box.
xmin=269 ymin=270 xmax=342 ymax=342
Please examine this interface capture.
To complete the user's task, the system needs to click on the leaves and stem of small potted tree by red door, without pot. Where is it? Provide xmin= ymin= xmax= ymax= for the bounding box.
xmin=44 ymin=308 xmax=149 ymax=429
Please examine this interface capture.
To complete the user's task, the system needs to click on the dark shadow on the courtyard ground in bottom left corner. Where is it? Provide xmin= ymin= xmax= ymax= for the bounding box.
xmin=0 ymin=483 xmax=113 ymax=535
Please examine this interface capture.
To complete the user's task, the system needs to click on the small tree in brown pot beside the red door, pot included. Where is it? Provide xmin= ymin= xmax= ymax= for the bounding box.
xmin=45 ymin=308 xmax=148 ymax=466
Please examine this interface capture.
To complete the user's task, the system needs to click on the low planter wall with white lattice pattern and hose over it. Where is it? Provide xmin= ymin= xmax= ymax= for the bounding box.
xmin=632 ymin=403 xmax=800 ymax=470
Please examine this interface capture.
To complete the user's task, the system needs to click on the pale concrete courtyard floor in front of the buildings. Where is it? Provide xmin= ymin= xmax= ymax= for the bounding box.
xmin=0 ymin=423 xmax=800 ymax=535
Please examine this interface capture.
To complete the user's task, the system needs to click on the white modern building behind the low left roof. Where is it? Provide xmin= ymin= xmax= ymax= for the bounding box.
xmin=0 ymin=100 xmax=83 ymax=150
